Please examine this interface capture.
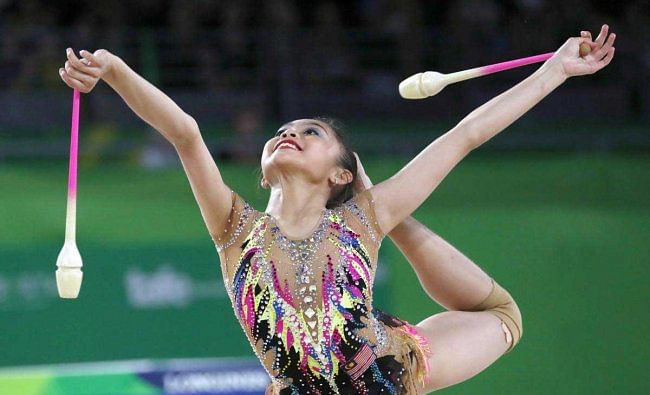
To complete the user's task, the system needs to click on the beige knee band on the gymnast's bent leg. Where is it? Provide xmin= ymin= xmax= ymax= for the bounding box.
xmin=468 ymin=278 xmax=524 ymax=354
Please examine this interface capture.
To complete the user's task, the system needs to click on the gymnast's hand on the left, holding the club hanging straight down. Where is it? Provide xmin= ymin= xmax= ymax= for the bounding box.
xmin=59 ymin=48 xmax=114 ymax=93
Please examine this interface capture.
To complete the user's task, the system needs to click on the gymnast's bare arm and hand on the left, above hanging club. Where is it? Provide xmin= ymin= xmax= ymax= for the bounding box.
xmin=59 ymin=48 xmax=232 ymax=243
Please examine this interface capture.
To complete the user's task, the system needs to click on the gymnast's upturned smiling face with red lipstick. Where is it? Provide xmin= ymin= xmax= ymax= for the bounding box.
xmin=261 ymin=119 xmax=341 ymax=186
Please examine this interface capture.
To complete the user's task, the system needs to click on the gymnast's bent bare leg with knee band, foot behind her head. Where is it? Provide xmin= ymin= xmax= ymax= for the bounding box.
xmin=356 ymin=156 xmax=523 ymax=393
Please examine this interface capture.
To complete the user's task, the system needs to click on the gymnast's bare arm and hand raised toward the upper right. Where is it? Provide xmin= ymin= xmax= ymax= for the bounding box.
xmin=370 ymin=31 xmax=615 ymax=238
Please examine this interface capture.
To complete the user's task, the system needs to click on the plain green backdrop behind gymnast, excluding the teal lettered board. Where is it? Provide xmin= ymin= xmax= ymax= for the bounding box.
xmin=0 ymin=152 xmax=650 ymax=394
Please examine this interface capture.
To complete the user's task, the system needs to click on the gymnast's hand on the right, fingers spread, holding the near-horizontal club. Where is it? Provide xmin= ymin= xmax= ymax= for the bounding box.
xmin=548 ymin=25 xmax=616 ymax=78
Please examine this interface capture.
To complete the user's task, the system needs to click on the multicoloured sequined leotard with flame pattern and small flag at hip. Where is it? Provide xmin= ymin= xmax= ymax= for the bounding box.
xmin=213 ymin=190 xmax=427 ymax=394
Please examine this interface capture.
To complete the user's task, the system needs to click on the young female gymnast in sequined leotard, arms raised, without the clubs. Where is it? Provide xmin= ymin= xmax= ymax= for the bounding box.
xmin=59 ymin=25 xmax=615 ymax=394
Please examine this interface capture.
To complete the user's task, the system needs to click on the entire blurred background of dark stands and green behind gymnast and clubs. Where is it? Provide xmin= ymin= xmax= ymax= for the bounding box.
xmin=0 ymin=0 xmax=650 ymax=395
